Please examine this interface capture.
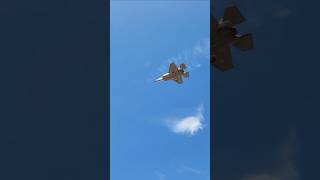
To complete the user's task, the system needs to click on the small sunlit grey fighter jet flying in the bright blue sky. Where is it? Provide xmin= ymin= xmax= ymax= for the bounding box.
xmin=156 ymin=63 xmax=189 ymax=84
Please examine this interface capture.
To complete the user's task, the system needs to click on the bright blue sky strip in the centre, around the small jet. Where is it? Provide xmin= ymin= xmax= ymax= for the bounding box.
xmin=110 ymin=1 xmax=210 ymax=180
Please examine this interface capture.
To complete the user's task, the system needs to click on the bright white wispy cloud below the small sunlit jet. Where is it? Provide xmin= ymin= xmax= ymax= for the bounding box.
xmin=167 ymin=105 xmax=204 ymax=136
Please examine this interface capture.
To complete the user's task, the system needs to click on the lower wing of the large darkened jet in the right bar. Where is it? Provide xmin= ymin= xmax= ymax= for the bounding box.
xmin=213 ymin=46 xmax=233 ymax=71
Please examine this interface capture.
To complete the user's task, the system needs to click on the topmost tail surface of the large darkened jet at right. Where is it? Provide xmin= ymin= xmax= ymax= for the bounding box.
xmin=223 ymin=6 xmax=246 ymax=26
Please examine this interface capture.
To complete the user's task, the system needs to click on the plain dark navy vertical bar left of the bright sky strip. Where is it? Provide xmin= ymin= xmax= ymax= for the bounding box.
xmin=0 ymin=0 xmax=110 ymax=180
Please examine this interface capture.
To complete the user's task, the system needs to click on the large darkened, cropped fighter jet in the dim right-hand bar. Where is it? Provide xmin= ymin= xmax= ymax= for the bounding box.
xmin=210 ymin=6 xmax=253 ymax=71
